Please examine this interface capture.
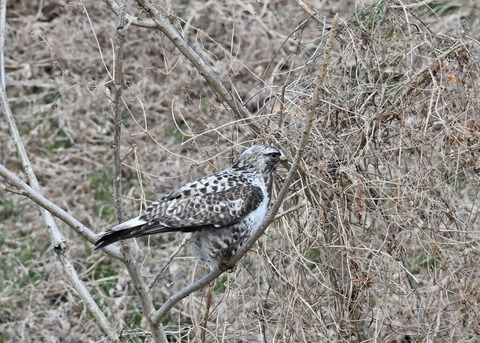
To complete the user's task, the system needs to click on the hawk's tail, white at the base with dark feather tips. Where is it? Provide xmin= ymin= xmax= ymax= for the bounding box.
xmin=95 ymin=217 xmax=176 ymax=250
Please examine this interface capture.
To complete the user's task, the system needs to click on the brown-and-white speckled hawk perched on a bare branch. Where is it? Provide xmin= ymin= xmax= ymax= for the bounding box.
xmin=95 ymin=145 xmax=288 ymax=267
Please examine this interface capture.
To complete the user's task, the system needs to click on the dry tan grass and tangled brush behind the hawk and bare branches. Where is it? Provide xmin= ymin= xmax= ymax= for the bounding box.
xmin=0 ymin=1 xmax=480 ymax=342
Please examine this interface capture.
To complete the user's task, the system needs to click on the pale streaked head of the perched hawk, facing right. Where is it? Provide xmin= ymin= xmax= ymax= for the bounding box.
xmin=233 ymin=145 xmax=288 ymax=173
